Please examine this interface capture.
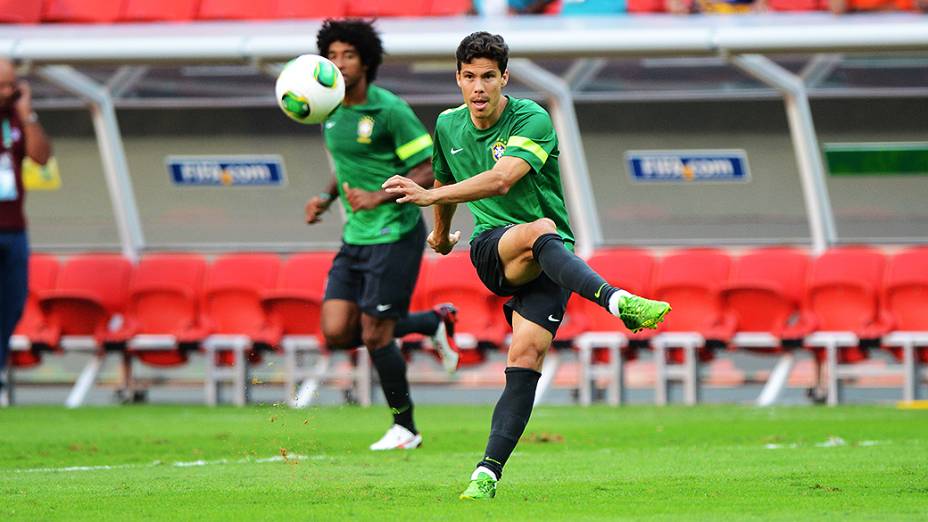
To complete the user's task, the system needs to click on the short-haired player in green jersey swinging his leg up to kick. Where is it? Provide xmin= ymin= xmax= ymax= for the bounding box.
xmin=383 ymin=32 xmax=670 ymax=499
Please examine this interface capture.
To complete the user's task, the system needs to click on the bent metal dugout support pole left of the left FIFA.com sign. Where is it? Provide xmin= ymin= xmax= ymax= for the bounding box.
xmin=36 ymin=65 xmax=145 ymax=261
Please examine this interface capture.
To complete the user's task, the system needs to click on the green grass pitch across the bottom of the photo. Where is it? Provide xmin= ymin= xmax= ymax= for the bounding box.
xmin=0 ymin=406 xmax=928 ymax=522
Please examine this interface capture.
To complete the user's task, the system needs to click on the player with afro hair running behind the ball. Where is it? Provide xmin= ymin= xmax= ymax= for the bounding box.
xmin=306 ymin=20 xmax=458 ymax=450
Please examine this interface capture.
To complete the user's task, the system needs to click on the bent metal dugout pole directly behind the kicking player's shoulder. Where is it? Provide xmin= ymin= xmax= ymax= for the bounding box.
xmin=509 ymin=58 xmax=603 ymax=257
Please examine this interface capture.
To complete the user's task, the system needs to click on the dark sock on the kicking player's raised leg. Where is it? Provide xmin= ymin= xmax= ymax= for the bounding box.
xmin=532 ymin=234 xmax=618 ymax=309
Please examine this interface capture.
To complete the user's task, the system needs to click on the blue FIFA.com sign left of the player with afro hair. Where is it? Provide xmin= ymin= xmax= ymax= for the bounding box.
xmin=165 ymin=154 xmax=287 ymax=187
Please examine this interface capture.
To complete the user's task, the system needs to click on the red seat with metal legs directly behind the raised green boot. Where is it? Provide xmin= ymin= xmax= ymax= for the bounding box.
xmin=558 ymin=248 xmax=654 ymax=405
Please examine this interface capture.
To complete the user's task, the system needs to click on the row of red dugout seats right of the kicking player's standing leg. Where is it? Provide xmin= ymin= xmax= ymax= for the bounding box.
xmin=558 ymin=247 xmax=928 ymax=363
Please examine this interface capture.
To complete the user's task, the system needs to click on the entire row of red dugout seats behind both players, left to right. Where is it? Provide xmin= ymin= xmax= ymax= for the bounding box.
xmin=14 ymin=247 xmax=928 ymax=366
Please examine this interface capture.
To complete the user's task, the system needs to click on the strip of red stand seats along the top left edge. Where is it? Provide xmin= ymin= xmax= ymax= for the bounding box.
xmin=0 ymin=0 xmax=470 ymax=23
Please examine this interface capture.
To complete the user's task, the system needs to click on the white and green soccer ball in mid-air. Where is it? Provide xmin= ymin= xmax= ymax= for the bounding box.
xmin=275 ymin=54 xmax=345 ymax=124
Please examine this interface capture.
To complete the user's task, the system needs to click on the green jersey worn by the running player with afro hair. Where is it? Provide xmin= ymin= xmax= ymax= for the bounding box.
xmin=322 ymin=85 xmax=432 ymax=245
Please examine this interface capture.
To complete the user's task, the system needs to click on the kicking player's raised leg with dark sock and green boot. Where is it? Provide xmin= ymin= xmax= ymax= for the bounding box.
xmin=500 ymin=218 xmax=671 ymax=332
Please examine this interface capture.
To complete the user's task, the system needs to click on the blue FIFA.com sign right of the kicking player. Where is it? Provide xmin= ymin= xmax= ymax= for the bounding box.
xmin=625 ymin=150 xmax=751 ymax=183
